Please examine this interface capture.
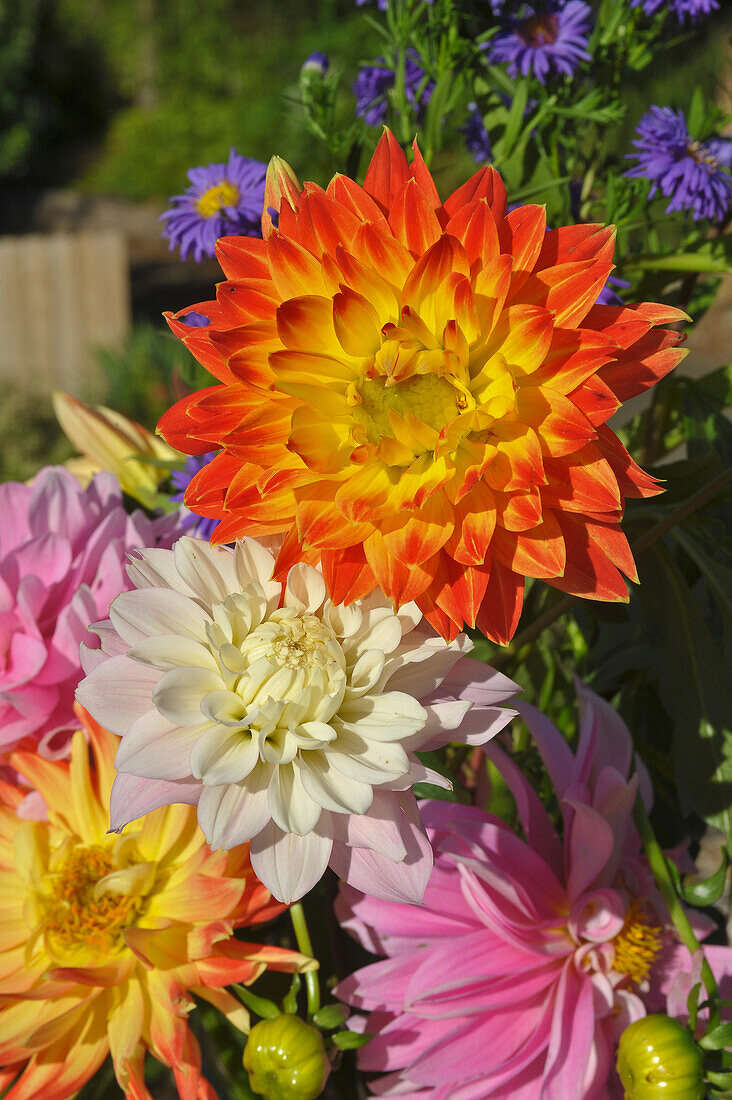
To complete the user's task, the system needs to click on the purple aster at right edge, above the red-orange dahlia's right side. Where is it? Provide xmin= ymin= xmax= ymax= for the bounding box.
xmin=625 ymin=107 xmax=732 ymax=221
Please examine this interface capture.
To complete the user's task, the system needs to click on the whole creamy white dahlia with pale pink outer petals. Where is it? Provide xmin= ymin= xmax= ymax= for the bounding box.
xmin=77 ymin=537 xmax=516 ymax=902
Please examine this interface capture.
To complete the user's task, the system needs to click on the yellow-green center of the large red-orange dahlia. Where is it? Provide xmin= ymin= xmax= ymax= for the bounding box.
xmin=350 ymin=374 xmax=466 ymax=443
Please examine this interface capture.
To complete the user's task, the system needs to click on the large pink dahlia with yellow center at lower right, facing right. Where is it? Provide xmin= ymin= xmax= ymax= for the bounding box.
xmin=336 ymin=685 xmax=732 ymax=1100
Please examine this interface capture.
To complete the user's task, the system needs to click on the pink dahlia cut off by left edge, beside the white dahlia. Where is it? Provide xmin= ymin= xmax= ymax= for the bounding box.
xmin=0 ymin=466 xmax=175 ymax=759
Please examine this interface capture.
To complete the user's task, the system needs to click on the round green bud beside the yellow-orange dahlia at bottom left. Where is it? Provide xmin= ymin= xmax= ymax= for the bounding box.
xmin=243 ymin=1012 xmax=330 ymax=1100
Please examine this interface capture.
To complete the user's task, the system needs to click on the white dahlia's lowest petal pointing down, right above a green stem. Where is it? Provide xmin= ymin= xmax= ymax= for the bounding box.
xmin=251 ymin=815 xmax=332 ymax=905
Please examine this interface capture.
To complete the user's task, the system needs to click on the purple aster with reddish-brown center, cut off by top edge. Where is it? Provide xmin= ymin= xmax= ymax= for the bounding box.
xmin=484 ymin=0 xmax=592 ymax=84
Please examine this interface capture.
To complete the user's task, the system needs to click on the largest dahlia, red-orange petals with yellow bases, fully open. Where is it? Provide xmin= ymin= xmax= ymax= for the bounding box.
xmin=160 ymin=131 xmax=685 ymax=641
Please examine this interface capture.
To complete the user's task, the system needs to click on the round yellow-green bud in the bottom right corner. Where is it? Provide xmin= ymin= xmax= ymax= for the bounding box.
xmin=618 ymin=1015 xmax=707 ymax=1100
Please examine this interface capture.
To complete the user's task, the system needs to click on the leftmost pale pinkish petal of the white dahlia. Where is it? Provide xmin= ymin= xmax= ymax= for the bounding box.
xmin=76 ymin=657 xmax=160 ymax=735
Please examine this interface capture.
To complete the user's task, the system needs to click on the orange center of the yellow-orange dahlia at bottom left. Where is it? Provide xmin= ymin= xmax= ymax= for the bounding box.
xmin=41 ymin=846 xmax=136 ymax=957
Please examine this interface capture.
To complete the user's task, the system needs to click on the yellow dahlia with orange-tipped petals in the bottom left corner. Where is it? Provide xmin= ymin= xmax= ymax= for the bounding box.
xmin=0 ymin=708 xmax=314 ymax=1100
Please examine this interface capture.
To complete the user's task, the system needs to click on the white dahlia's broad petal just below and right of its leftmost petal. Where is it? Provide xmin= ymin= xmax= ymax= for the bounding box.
xmin=114 ymin=711 xmax=206 ymax=779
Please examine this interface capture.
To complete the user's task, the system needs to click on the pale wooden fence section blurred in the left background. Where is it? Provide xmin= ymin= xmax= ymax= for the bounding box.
xmin=0 ymin=230 xmax=130 ymax=397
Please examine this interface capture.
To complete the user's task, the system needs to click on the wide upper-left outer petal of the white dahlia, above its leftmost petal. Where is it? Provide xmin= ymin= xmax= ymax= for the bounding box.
xmin=109 ymin=589 xmax=210 ymax=646
